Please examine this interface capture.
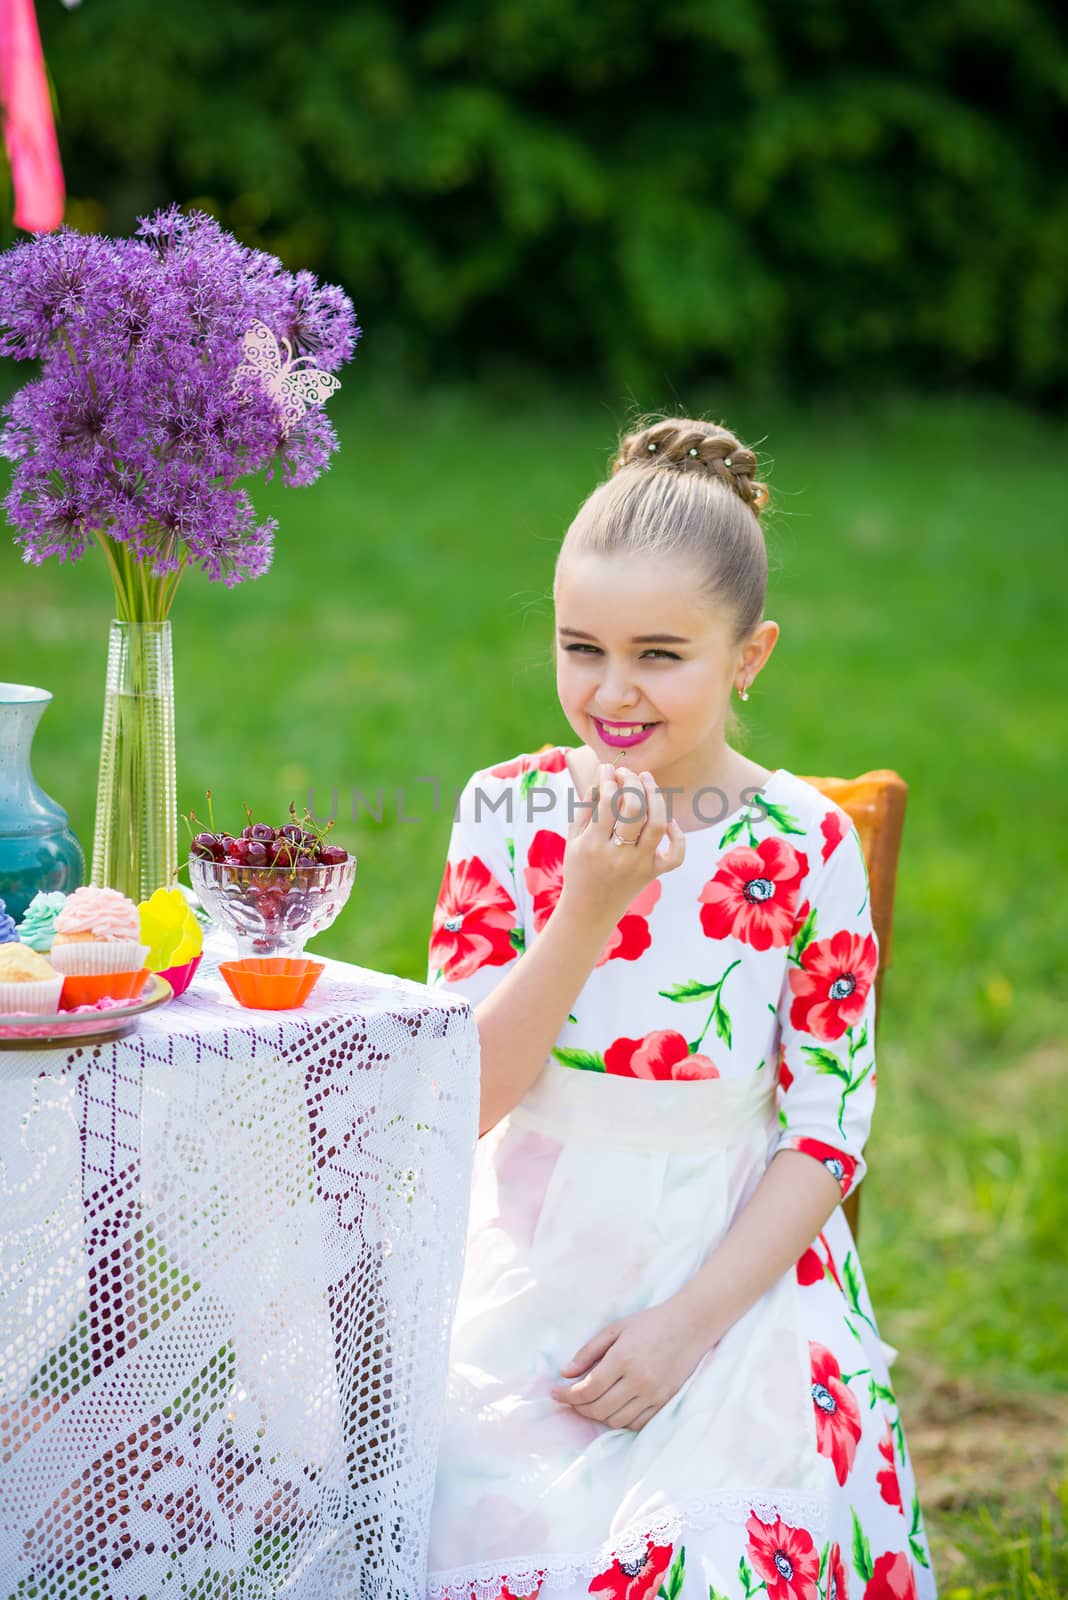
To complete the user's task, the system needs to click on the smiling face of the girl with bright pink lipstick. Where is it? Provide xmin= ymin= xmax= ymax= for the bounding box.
xmin=556 ymin=555 xmax=779 ymax=787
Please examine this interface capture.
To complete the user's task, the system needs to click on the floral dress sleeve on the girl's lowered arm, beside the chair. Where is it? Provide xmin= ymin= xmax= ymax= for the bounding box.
xmin=772 ymin=810 xmax=879 ymax=1198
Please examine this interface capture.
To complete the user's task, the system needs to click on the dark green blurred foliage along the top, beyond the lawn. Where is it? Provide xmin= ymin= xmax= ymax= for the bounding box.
xmin=29 ymin=0 xmax=1068 ymax=400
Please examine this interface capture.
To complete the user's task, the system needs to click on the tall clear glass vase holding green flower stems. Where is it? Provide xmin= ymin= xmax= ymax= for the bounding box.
xmin=91 ymin=621 xmax=177 ymax=901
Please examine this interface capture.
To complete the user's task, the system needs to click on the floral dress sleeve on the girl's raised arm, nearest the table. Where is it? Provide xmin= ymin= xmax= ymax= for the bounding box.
xmin=427 ymin=771 xmax=524 ymax=1005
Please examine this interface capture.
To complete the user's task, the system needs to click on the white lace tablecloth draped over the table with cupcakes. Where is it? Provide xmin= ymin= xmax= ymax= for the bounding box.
xmin=0 ymin=962 xmax=478 ymax=1600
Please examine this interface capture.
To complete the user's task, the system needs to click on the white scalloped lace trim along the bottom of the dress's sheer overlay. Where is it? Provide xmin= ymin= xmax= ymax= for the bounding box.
xmin=427 ymin=1490 xmax=827 ymax=1600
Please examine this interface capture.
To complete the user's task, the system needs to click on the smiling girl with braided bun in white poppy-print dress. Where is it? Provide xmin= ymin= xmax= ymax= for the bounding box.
xmin=428 ymin=419 xmax=935 ymax=1600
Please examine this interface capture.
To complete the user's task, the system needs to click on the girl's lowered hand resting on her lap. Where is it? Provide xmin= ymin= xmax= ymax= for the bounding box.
xmin=550 ymin=1298 xmax=711 ymax=1434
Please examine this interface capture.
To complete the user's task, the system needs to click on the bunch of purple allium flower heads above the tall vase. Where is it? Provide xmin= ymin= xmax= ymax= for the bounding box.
xmin=0 ymin=206 xmax=360 ymax=592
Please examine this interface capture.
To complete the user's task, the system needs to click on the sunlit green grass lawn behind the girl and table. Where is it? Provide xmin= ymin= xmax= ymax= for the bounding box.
xmin=0 ymin=377 xmax=1068 ymax=1597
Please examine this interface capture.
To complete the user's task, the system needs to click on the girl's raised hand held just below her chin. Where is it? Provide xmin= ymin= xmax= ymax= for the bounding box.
xmin=561 ymin=762 xmax=686 ymax=926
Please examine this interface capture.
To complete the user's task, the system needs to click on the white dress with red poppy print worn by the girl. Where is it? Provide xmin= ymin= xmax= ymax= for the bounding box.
xmin=428 ymin=747 xmax=935 ymax=1600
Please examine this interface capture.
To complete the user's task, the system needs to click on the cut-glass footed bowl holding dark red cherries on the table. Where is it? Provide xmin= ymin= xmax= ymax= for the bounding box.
xmin=189 ymin=856 xmax=357 ymax=960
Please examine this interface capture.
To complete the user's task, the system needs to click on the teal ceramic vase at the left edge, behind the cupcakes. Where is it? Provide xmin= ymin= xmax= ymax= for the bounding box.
xmin=0 ymin=683 xmax=85 ymax=922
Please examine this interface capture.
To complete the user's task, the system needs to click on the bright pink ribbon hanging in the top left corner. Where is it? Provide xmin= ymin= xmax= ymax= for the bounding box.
xmin=0 ymin=0 xmax=66 ymax=234
